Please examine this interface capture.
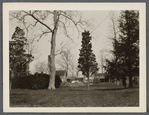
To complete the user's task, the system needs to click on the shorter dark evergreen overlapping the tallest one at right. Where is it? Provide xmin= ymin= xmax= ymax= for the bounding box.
xmin=104 ymin=39 xmax=126 ymax=88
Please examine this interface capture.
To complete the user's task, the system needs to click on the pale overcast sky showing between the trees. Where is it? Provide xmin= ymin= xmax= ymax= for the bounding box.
xmin=9 ymin=11 xmax=120 ymax=72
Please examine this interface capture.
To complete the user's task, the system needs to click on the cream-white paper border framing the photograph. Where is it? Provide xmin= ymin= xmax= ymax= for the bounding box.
xmin=2 ymin=2 xmax=147 ymax=113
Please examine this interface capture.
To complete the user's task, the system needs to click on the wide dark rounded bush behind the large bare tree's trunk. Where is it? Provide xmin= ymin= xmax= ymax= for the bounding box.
xmin=12 ymin=73 xmax=61 ymax=89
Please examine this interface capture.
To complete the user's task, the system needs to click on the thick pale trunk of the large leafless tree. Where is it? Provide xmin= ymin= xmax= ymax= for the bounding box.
xmin=48 ymin=11 xmax=58 ymax=90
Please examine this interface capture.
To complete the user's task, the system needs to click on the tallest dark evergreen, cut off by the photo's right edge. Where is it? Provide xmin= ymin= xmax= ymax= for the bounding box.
xmin=119 ymin=10 xmax=139 ymax=87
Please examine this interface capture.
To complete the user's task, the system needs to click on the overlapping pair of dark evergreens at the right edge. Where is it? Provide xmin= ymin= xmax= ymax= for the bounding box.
xmin=105 ymin=10 xmax=139 ymax=87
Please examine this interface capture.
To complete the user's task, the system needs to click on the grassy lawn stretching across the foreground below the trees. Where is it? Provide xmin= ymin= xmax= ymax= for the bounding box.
xmin=10 ymin=83 xmax=139 ymax=107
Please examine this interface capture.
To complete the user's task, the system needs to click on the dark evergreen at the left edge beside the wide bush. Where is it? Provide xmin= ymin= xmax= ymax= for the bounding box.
xmin=9 ymin=27 xmax=33 ymax=89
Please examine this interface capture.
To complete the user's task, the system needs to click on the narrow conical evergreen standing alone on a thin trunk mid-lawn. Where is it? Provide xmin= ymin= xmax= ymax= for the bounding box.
xmin=78 ymin=31 xmax=98 ymax=90
